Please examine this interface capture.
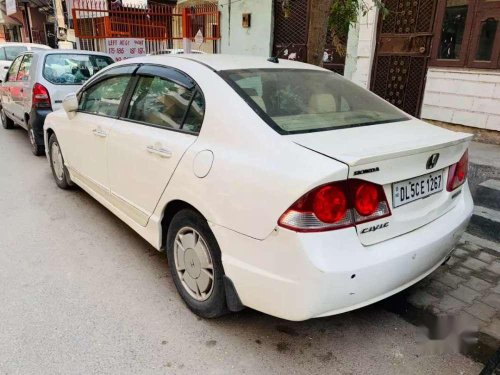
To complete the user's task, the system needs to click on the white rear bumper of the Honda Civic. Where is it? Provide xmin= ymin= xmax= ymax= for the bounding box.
xmin=212 ymin=184 xmax=473 ymax=320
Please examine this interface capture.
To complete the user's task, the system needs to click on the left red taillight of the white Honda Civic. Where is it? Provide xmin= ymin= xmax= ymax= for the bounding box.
xmin=278 ymin=180 xmax=391 ymax=232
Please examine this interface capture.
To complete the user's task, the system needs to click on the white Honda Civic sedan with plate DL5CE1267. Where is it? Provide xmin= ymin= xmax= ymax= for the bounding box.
xmin=45 ymin=55 xmax=473 ymax=320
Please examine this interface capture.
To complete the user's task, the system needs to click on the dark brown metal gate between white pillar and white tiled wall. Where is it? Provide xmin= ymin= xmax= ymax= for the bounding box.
xmin=371 ymin=0 xmax=437 ymax=116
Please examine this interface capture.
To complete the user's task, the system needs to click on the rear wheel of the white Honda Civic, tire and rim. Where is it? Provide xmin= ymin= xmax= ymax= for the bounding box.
xmin=166 ymin=209 xmax=228 ymax=318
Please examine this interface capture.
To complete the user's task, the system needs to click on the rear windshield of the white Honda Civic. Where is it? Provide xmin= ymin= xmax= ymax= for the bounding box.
xmin=221 ymin=69 xmax=409 ymax=134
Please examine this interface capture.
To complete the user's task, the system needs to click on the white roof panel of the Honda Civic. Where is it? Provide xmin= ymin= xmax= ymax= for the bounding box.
xmin=119 ymin=54 xmax=326 ymax=71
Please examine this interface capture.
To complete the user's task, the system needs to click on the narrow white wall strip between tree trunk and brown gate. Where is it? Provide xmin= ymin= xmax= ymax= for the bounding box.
xmin=344 ymin=0 xmax=378 ymax=88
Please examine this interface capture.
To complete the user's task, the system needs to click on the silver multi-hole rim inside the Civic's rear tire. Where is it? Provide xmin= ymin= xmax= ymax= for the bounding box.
xmin=174 ymin=227 xmax=214 ymax=301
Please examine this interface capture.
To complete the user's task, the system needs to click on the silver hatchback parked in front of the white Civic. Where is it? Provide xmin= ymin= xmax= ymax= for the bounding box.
xmin=0 ymin=50 xmax=113 ymax=155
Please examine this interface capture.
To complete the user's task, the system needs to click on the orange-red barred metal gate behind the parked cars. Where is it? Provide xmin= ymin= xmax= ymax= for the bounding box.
xmin=72 ymin=0 xmax=220 ymax=53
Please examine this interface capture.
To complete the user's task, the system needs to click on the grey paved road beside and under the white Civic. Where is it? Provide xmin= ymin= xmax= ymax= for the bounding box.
xmin=0 ymin=129 xmax=481 ymax=375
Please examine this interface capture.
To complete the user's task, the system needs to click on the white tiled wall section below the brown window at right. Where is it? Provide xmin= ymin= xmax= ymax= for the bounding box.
xmin=421 ymin=68 xmax=500 ymax=131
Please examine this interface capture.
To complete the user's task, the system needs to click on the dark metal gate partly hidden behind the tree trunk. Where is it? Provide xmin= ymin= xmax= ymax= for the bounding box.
xmin=273 ymin=0 xmax=347 ymax=74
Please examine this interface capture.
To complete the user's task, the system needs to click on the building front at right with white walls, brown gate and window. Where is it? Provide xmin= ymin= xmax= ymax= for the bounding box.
xmin=345 ymin=0 xmax=500 ymax=132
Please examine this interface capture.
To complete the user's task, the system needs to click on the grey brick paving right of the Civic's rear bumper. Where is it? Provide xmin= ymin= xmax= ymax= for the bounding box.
xmin=381 ymin=238 xmax=500 ymax=364
